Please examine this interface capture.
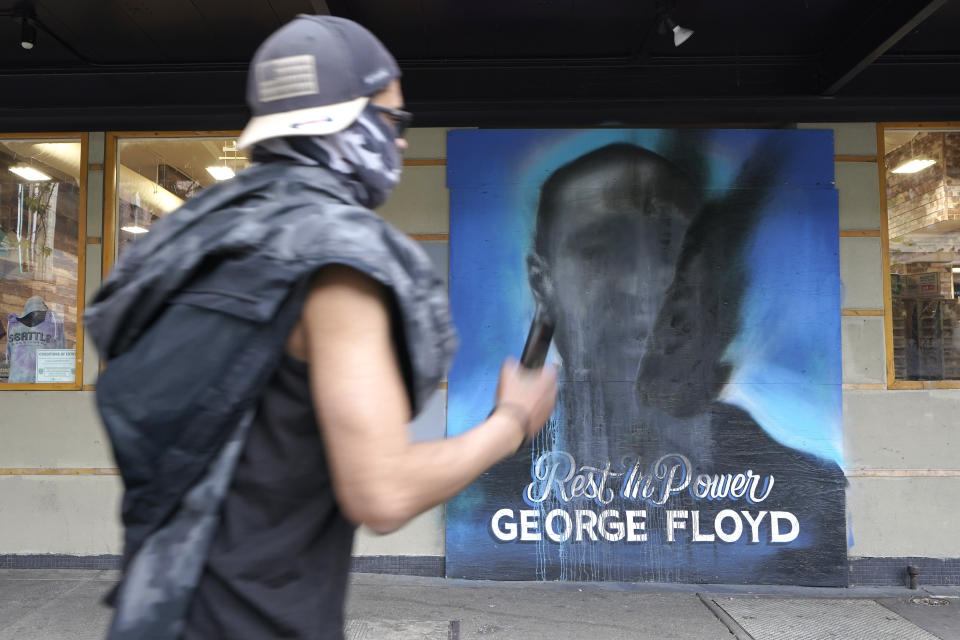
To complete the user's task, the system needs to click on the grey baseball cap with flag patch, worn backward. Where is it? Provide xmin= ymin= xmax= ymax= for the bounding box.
xmin=237 ymin=15 xmax=400 ymax=149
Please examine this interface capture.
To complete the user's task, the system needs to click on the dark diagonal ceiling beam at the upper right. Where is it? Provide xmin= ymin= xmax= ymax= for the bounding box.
xmin=821 ymin=0 xmax=947 ymax=96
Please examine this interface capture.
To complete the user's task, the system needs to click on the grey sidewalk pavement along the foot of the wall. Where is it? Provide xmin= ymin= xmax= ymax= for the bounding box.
xmin=0 ymin=569 xmax=960 ymax=640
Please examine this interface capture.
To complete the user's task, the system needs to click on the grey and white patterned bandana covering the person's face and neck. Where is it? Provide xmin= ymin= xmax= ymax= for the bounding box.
xmin=252 ymin=104 xmax=403 ymax=209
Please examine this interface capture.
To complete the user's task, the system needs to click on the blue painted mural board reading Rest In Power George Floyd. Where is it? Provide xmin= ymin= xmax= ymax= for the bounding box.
xmin=446 ymin=129 xmax=847 ymax=585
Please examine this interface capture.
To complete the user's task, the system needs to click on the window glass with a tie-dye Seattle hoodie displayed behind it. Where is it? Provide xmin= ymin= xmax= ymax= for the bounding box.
xmin=0 ymin=139 xmax=85 ymax=384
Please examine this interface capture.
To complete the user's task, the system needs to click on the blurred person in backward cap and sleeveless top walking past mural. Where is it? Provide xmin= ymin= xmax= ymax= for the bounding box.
xmin=86 ymin=15 xmax=556 ymax=640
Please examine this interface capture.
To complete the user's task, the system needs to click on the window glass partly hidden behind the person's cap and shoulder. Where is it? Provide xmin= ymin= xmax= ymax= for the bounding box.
xmin=116 ymin=137 xmax=249 ymax=257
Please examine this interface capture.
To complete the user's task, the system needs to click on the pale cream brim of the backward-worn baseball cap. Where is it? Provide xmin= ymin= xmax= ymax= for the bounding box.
xmin=237 ymin=96 xmax=370 ymax=149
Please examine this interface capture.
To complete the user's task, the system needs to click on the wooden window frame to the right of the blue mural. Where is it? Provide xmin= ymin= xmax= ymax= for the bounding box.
xmin=877 ymin=121 xmax=960 ymax=391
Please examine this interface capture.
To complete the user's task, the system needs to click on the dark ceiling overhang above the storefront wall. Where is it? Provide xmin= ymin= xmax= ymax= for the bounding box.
xmin=0 ymin=0 xmax=960 ymax=131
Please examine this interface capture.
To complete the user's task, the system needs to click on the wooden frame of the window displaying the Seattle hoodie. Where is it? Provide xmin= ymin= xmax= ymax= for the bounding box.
xmin=0 ymin=131 xmax=92 ymax=391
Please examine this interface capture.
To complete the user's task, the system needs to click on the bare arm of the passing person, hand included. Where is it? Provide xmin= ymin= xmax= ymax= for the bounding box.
xmin=300 ymin=266 xmax=556 ymax=533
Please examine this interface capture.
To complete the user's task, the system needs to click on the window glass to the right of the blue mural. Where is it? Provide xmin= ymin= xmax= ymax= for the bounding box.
xmin=884 ymin=129 xmax=960 ymax=380
